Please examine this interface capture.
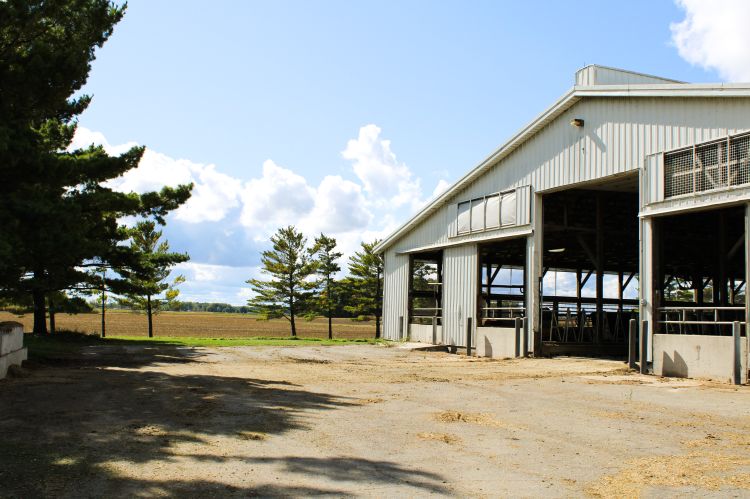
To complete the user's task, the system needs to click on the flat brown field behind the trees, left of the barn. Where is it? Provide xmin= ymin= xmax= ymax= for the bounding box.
xmin=0 ymin=310 xmax=375 ymax=339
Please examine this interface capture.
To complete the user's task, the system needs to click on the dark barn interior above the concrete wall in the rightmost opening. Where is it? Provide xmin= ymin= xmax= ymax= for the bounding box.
xmin=654 ymin=205 xmax=747 ymax=336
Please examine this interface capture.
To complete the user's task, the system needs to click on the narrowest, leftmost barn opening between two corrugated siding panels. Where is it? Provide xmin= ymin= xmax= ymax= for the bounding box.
xmin=408 ymin=251 xmax=443 ymax=345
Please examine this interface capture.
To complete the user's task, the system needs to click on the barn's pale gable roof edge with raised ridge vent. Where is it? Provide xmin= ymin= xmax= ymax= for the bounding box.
xmin=374 ymin=65 xmax=750 ymax=253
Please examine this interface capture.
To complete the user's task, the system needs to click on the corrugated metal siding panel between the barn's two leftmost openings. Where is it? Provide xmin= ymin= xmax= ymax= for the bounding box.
xmin=443 ymin=244 xmax=478 ymax=347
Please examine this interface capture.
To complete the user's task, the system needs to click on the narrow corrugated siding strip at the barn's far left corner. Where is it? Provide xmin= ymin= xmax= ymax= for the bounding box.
xmin=383 ymin=249 xmax=409 ymax=340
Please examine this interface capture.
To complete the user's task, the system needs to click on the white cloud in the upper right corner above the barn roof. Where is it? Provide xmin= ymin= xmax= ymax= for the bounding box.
xmin=670 ymin=0 xmax=750 ymax=82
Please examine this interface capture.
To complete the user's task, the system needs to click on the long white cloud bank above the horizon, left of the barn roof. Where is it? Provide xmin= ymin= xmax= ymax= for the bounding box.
xmin=70 ymin=125 xmax=449 ymax=304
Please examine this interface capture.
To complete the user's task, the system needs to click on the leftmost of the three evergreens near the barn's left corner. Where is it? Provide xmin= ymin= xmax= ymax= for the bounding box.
xmin=247 ymin=225 xmax=316 ymax=336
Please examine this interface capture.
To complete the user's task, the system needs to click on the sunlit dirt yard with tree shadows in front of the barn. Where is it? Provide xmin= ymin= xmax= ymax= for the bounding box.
xmin=0 ymin=345 xmax=750 ymax=498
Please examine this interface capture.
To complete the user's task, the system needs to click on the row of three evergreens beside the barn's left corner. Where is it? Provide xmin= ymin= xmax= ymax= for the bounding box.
xmin=247 ymin=226 xmax=383 ymax=338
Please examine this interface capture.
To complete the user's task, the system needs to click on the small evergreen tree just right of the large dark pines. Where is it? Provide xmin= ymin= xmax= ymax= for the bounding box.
xmin=120 ymin=220 xmax=190 ymax=338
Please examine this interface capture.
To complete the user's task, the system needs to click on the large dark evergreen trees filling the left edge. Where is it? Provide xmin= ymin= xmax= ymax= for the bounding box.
xmin=0 ymin=0 xmax=192 ymax=334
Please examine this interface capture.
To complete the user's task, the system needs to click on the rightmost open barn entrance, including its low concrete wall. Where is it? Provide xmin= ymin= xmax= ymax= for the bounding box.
xmin=650 ymin=205 xmax=747 ymax=382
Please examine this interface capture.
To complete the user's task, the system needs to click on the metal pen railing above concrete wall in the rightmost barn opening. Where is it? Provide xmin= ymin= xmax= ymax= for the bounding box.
xmin=658 ymin=306 xmax=746 ymax=336
